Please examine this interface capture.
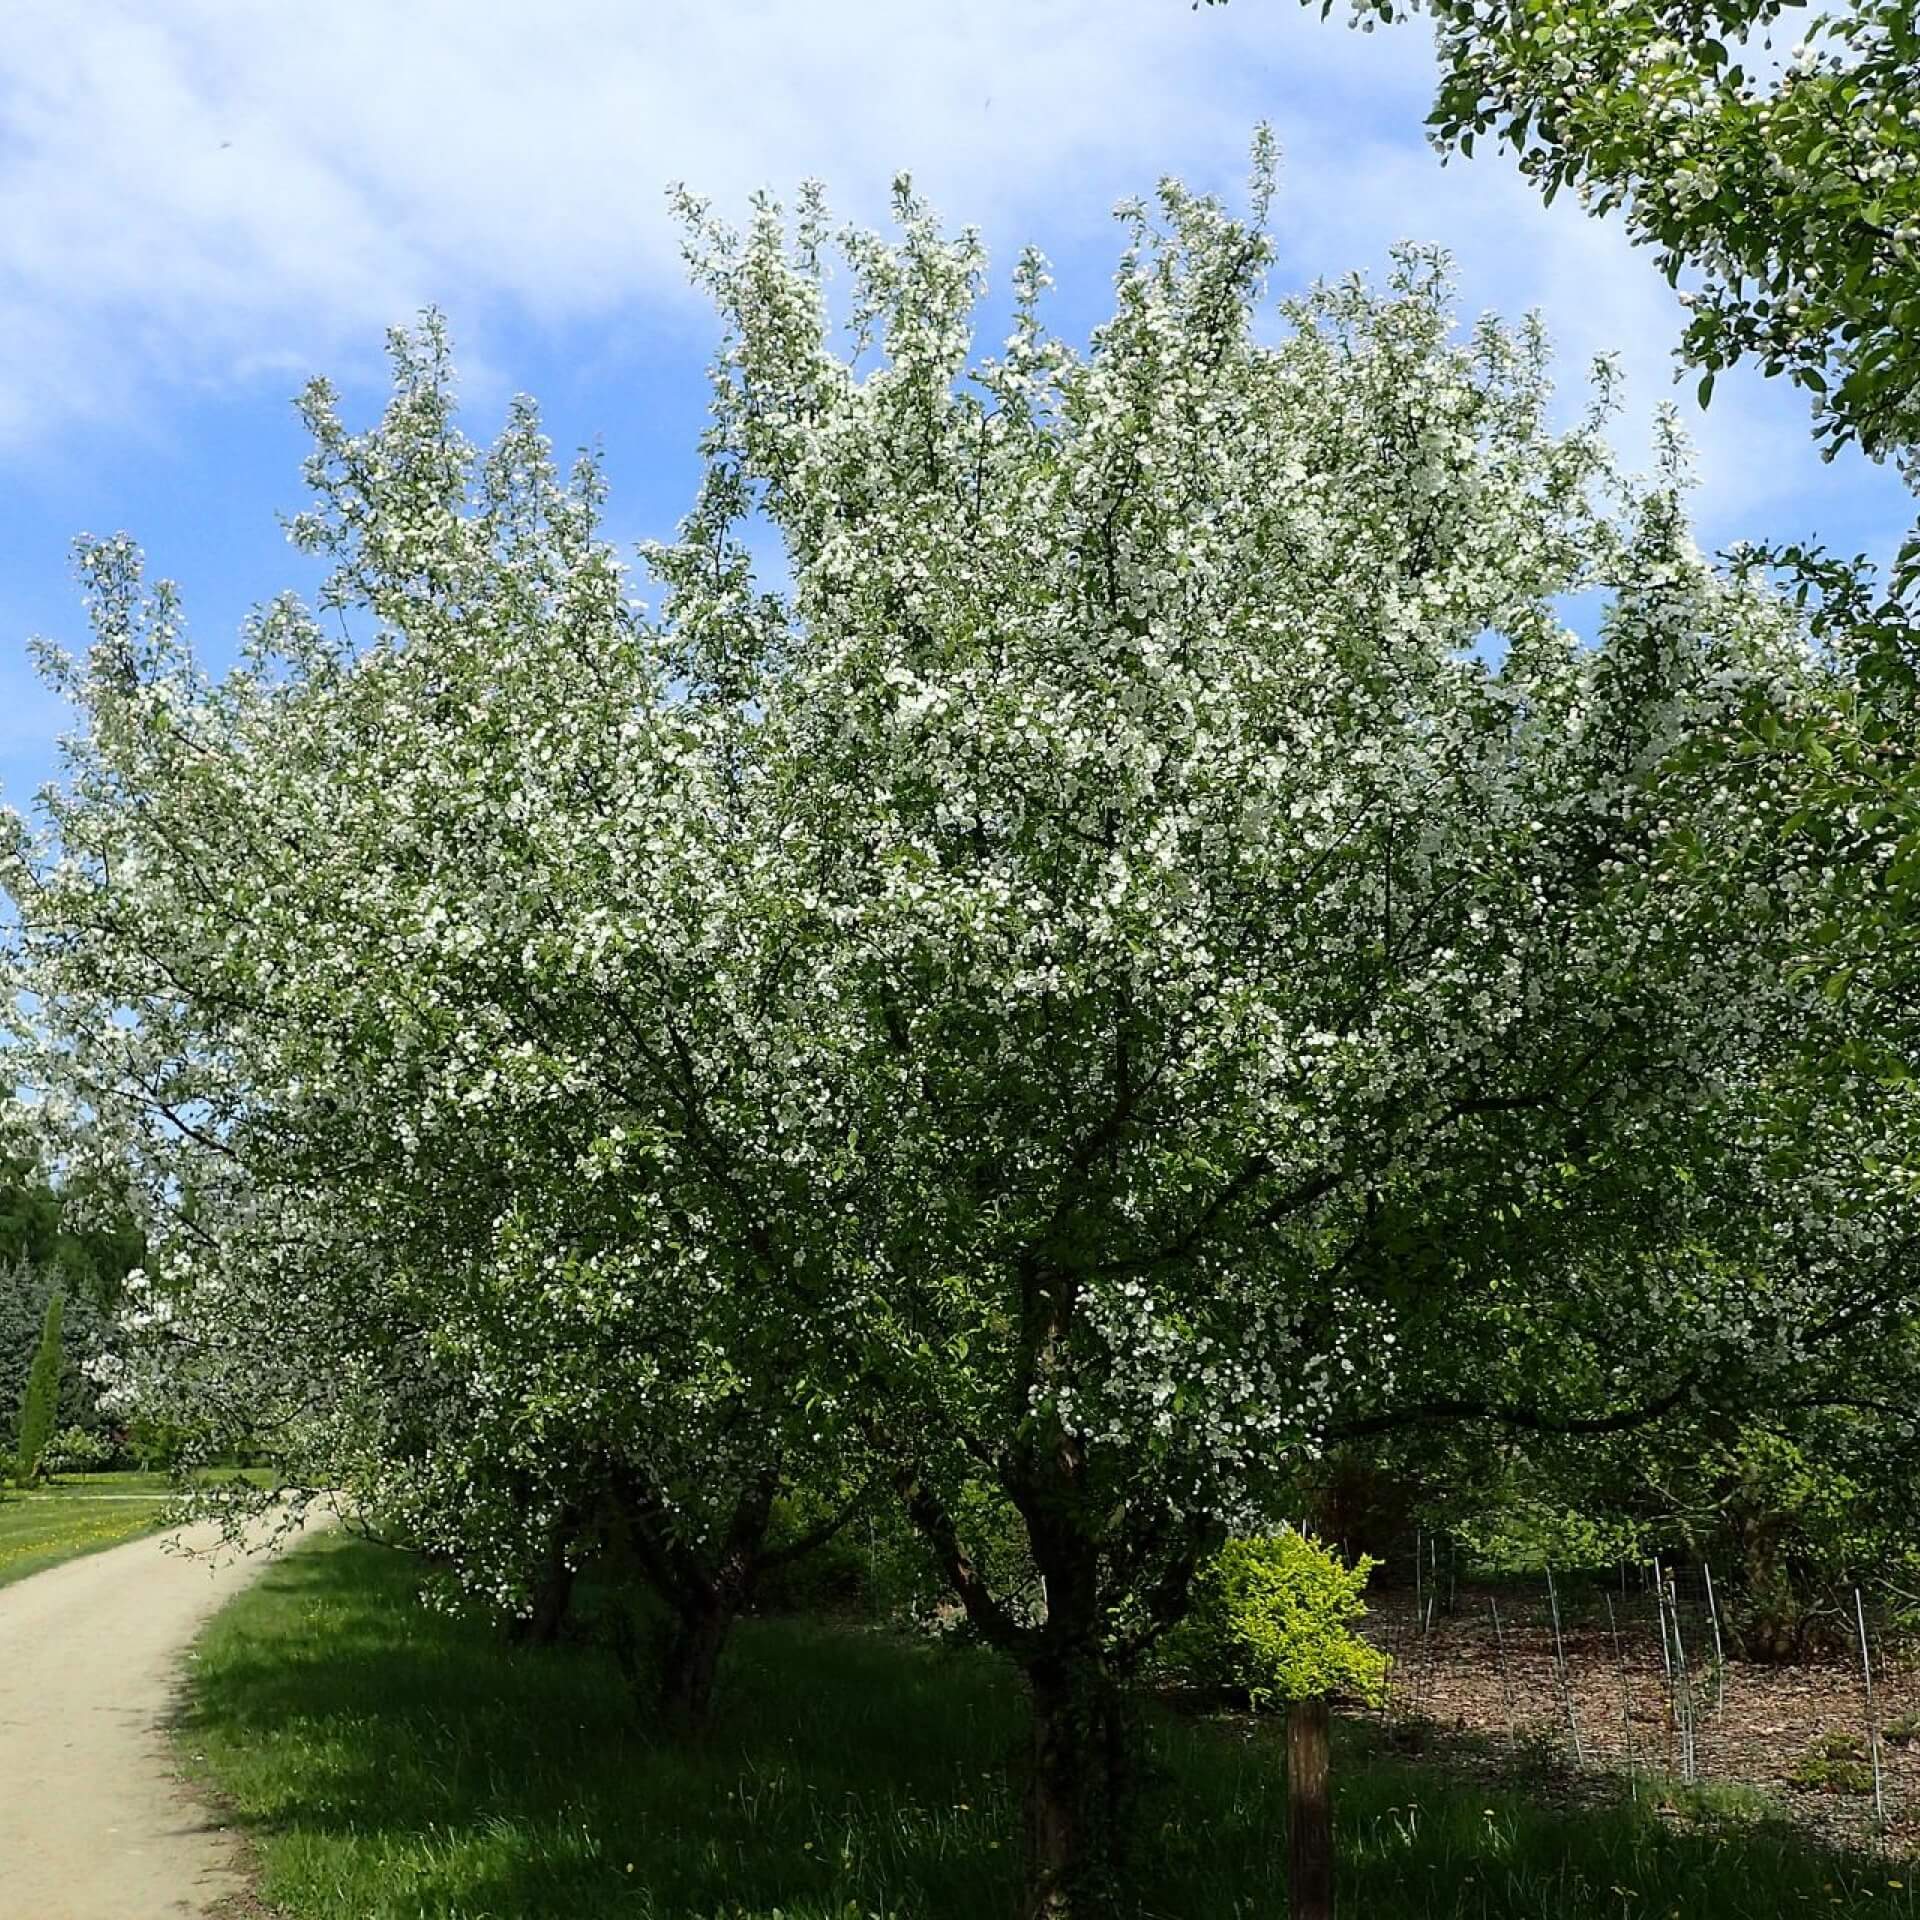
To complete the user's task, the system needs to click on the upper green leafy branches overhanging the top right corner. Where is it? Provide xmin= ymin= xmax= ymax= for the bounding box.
xmin=1259 ymin=0 xmax=1920 ymax=518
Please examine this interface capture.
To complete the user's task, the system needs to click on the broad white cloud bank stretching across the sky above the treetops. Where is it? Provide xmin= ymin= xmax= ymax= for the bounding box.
xmin=0 ymin=0 xmax=1904 ymax=552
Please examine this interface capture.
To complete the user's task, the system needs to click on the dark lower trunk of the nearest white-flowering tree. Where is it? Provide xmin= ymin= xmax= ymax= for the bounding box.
xmin=1021 ymin=1651 xmax=1131 ymax=1920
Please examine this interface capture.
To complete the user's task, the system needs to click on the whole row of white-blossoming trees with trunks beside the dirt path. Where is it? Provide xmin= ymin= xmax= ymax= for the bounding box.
xmin=4 ymin=153 xmax=1914 ymax=1916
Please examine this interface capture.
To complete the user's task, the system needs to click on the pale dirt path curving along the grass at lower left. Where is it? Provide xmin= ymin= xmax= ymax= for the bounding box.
xmin=0 ymin=1528 xmax=318 ymax=1920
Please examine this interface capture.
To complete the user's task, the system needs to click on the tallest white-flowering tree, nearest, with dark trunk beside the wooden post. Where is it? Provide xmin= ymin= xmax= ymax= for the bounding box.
xmin=645 ymin=172 xmax=1873 ymax=1910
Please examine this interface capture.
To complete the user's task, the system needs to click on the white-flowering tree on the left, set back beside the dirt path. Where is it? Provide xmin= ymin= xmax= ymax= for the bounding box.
xmin=10 ymin=341 xmax=840 ymax=1722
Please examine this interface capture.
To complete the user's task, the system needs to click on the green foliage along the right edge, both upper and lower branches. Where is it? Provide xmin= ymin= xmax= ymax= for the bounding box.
xmin=1213 ymin=0 xmax=1920 ymax=1244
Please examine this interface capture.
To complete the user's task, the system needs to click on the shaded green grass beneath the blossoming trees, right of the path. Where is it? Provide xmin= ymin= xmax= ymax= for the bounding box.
xmin=180 ymin=1536 xmax=1916 ymax=1920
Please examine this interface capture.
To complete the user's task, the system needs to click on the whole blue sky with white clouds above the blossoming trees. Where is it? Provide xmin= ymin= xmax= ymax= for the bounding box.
xmin=0 ymin=0 xmax=1908 ymax=803
